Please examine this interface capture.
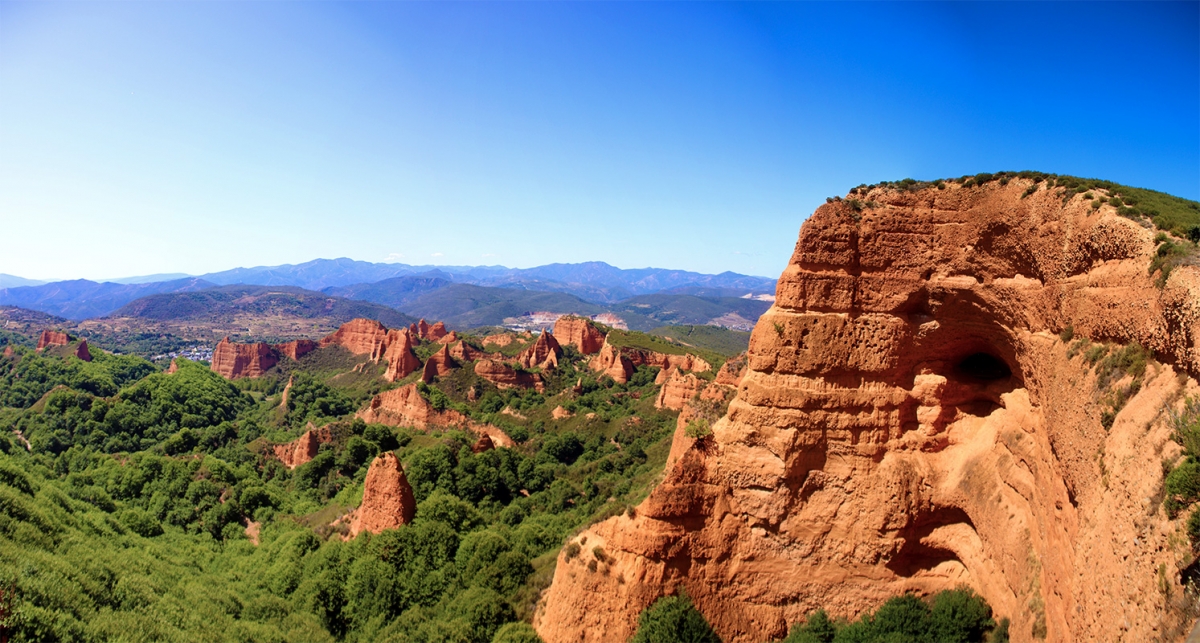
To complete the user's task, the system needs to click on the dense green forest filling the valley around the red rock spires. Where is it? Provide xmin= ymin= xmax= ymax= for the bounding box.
xmin=0 ymin=333 xmax=993 ymax=643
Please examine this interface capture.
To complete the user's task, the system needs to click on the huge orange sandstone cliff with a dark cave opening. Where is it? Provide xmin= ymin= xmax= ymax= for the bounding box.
xmin=535 ymin=180 xmax=1200 ymax=643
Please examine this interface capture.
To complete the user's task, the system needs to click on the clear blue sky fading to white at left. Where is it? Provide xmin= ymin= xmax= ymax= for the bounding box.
xmin=0 ymin=1 xmax=1200 ymax=278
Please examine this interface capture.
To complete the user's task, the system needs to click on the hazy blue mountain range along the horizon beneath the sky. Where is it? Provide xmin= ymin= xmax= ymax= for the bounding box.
xmin=0 ymin=259 xmax=775 ymax=331
